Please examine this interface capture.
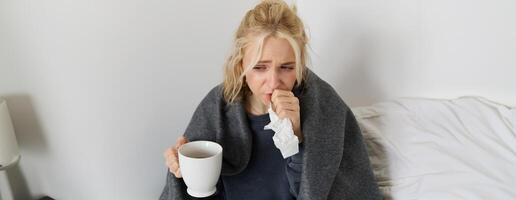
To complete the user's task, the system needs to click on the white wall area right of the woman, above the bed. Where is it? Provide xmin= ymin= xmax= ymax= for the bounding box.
xmin=298 ymin=0 xmax=516 ymax=106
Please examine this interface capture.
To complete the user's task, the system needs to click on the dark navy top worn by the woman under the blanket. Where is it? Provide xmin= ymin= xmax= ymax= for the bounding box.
xmin=222 ymin=114 xmax=302 ymax=200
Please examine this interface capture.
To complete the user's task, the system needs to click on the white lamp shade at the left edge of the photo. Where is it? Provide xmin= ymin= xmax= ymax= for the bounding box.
xmin=0 ymin=98 xmax=20 ymax=167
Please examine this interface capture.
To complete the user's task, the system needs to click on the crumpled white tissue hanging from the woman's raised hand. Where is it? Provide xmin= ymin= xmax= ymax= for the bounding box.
xmin=263 ymin=106 xmax=299 ymax=158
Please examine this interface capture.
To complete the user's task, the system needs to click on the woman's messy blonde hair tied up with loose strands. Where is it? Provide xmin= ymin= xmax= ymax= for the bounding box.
xmin=223 ymin=0 xmax=308 ymax=103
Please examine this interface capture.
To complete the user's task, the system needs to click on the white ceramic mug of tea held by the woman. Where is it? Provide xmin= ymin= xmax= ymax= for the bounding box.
xmin=179 ymin=141 xmax=222 ymax=198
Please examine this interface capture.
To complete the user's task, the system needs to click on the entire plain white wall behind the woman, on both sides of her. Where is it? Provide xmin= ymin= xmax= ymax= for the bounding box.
xmin=0 ymin=0 xmax=516 ymax=200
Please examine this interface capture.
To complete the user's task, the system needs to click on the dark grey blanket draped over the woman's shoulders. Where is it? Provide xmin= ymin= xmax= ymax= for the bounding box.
xmin=160 ymin=71 xmax=381 ymax=200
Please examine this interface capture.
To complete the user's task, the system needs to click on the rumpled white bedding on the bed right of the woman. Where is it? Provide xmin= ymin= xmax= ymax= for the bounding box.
xmin=353 ymin=97 xmax=516 ymax=200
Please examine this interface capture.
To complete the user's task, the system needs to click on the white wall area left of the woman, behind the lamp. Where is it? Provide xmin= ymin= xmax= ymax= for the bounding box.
xmin=0 ymin=0 xmax=252 ymax=200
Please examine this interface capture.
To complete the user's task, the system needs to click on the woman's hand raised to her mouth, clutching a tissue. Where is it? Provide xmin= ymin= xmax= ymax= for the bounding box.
xmin=271 ymin=89 xmax=303 ymax=143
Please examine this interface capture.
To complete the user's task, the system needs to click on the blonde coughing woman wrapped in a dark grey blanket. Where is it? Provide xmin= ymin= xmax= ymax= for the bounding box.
xmin=160 ymin=0 xmax=381 ymax=200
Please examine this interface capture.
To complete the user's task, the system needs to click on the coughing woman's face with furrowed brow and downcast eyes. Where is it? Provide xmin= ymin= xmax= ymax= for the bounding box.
xmin=242 ymin=37 xmax=296 ymax=106
